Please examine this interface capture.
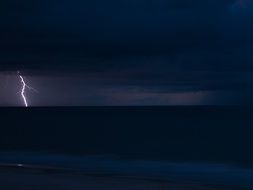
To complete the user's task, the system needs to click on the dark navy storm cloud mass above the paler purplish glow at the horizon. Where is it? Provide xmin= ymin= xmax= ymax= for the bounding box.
xmin=0 ymin=0 xmax=253 ymax=95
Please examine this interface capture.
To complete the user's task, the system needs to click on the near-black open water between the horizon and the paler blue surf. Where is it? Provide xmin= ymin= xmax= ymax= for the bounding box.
xmin=0 ymin=106 xmax=253 ymax=166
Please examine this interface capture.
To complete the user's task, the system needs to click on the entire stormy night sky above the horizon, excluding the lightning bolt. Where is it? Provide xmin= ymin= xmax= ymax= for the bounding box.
xmin=0 ymin=0 xmax=253 ymax=106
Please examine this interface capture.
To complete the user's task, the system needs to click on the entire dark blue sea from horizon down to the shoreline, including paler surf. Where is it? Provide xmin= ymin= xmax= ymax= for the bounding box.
xmin=0 ymin=106 xmax=253 ymax=189
